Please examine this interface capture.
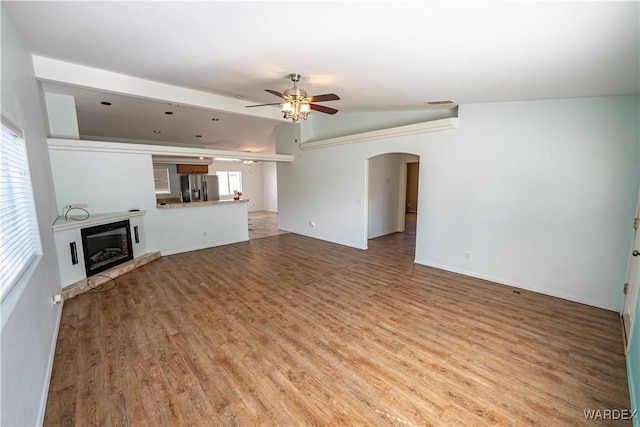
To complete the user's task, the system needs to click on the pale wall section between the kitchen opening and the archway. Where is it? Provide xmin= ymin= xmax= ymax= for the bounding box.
xmin=276 ymin=124 xmax=369 ymax=248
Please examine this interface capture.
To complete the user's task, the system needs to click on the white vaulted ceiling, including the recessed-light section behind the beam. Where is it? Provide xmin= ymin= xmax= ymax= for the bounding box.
xmin=1 ymin=1 xmax=640 ymax=152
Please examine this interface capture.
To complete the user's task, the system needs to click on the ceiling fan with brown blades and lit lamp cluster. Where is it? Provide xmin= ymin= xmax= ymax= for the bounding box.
xmin=247 ymin=73 xmax=340 ymax=122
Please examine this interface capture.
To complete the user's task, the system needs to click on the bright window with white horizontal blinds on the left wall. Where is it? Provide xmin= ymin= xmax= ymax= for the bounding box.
xmin=0 ymin=120 xmax=42 ymax=300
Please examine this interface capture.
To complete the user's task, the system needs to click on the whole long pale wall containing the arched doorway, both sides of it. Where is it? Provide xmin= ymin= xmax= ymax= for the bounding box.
xmin=276 ymin=96 xmax=640 ymax=310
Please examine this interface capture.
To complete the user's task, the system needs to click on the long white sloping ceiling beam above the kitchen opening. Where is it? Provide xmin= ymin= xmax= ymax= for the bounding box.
xmin=33 ymin=55 xmax=285 ymax=122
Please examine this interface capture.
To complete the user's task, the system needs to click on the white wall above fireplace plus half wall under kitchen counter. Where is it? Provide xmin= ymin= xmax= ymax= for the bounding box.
xmin=50 ymin=150 xmax=249 ymax=255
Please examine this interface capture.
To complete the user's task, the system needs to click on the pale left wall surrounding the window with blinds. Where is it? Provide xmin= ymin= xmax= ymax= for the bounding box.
xmin=0 ymin=10 xmax=62 ymax=426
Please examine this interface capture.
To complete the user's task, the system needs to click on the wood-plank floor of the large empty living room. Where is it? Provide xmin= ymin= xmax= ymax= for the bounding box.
xmin=45 ymin=216 xmax=630 ymax=426
